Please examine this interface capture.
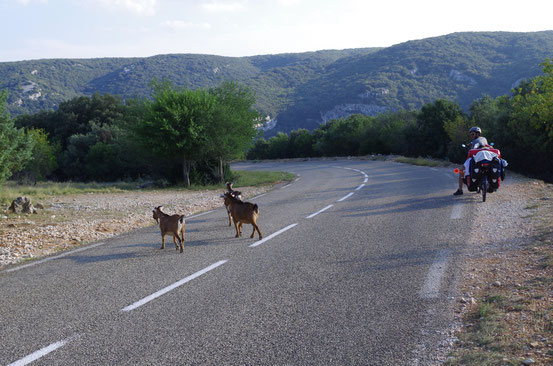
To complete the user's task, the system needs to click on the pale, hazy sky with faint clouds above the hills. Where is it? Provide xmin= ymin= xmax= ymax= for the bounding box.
xmin=0 ymin=0 xmax=553 ymax=62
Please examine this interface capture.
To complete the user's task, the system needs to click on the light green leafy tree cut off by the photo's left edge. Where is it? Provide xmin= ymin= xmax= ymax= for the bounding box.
xmin=0 ymin=91 xmax=34 ymax=185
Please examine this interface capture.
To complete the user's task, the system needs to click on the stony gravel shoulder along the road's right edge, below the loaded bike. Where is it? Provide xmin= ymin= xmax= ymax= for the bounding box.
xmin=442 ymin=174 xmax=553 ymax=365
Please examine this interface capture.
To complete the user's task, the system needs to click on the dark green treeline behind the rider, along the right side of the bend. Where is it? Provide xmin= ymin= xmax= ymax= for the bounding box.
xmin=247 ymin=59 xmax=553 ymax=182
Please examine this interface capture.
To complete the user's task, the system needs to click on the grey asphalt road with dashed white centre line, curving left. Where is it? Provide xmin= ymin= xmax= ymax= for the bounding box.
xmin=0 ymin=160 xmax=471 ymax=365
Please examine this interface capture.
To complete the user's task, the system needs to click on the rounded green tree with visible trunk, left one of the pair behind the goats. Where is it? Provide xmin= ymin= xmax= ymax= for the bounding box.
xmin=135 ymin=82 xmax=217 ymax=186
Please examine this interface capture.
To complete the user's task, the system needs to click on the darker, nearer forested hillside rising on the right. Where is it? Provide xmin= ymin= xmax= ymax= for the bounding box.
xmin=278 ymin=31 xmax=553 ymax=131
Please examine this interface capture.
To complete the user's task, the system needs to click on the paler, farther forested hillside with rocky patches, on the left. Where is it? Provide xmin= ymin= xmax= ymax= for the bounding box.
xmin=0 ymin=48 xmax=377 ymax=117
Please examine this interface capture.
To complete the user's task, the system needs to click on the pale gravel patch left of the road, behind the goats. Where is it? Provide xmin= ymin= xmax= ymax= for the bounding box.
xmin=0 ymin=186 xmax=270 ymax=268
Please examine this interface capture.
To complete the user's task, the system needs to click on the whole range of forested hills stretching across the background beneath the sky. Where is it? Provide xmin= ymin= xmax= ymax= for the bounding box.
xmin=0 ymin=31 xmax=553 ymax=134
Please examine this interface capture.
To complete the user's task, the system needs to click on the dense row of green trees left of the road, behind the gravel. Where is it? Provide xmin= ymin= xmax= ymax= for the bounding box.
xmin=0 ymin=81 xmax=259 ymax=185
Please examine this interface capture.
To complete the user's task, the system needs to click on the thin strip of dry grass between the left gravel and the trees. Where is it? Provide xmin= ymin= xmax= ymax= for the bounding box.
xmin=0 ymin=171 xmax=294 ymax=206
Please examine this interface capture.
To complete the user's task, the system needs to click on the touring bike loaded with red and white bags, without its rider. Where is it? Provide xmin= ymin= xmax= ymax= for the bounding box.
xmin=454 ymin=143 xmax=508 ymax=202
